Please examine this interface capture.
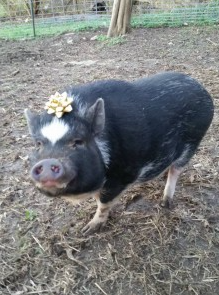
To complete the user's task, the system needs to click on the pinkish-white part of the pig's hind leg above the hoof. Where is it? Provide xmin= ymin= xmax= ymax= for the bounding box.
xmin=163 ymin=166 xmax=183 ymax=201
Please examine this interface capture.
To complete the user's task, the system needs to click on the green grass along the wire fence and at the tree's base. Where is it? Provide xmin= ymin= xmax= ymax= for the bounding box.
xmin=0 ymin=4 xmax=219 ymax=40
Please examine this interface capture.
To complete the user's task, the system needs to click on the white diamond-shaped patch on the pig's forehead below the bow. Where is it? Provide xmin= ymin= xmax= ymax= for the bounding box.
xmin=41 ymin=117 xmax=70 ymax=145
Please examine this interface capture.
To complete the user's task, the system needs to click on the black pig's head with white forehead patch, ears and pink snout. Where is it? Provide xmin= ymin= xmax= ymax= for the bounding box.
xmin=25 ymin=98 xmax=107 ymax=196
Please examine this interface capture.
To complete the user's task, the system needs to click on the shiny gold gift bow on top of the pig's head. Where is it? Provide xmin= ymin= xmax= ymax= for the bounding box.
xmin=45 ymin=92 xmax=73 ymax=118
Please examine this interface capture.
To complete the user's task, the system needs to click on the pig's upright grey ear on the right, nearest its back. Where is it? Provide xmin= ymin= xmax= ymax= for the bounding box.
xmin=87 ymin=98 xmax=105 ymax=135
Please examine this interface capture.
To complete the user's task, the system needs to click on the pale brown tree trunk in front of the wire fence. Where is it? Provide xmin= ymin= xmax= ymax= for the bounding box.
xmin=107 ymin=0 xmax=132 ymax=37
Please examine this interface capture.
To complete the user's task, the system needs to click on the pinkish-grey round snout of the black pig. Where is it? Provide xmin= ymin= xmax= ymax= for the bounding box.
xmin=31 ymin=159 xmax=64 ymax=182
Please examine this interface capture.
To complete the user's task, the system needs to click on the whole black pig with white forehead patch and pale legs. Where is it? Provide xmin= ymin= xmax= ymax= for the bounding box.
xmin=25 ymin=72 xmax=214 ymax=233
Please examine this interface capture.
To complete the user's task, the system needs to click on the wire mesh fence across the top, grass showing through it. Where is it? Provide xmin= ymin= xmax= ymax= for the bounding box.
xmin=0 ymin=0 xmax=219 ymax=38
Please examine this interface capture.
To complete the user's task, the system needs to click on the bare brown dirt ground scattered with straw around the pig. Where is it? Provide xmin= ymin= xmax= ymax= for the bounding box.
xmin=0 ymin=26 xmax=219 ymax=295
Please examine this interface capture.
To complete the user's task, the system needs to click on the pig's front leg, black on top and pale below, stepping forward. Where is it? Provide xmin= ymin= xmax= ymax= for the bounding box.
xmin=82 ymin=180 xmax=125 ymax=235
